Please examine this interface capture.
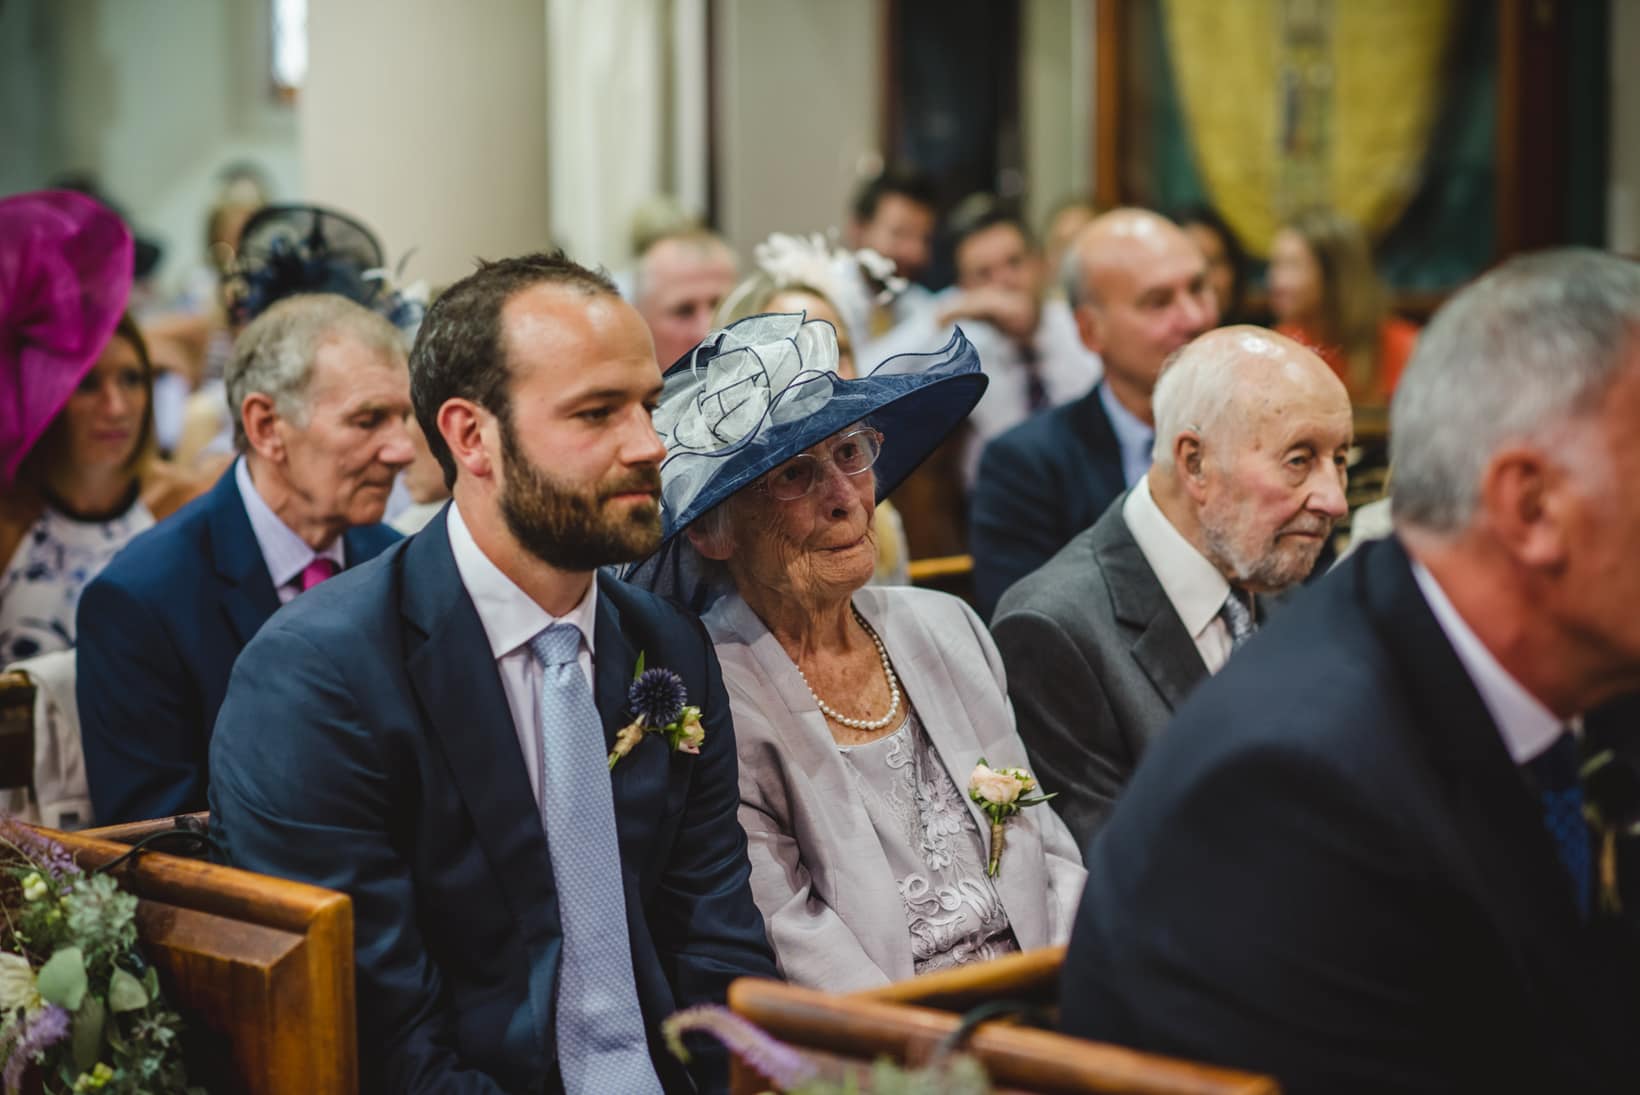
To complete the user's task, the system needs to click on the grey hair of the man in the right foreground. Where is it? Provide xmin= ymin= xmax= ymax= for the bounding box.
xmin=1389 ymin=248 xmax=1640 ymax=534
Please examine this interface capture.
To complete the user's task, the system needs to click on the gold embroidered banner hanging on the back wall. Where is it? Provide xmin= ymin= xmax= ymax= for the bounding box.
xmin=1161 ymin=0 xmax=1456 ymax=256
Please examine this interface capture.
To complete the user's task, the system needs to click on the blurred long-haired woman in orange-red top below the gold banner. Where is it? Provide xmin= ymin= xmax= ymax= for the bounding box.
xmin=1268 ymin=208 xmax=1419 ymax=405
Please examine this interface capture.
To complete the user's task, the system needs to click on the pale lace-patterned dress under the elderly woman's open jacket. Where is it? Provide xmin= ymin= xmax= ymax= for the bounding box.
xmin=838 ymin=715 xmax=1018 ymax=974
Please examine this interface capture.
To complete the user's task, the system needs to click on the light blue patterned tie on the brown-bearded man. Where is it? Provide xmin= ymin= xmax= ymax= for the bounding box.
xmin=530 ymin=623 xmax=661 ymax=1095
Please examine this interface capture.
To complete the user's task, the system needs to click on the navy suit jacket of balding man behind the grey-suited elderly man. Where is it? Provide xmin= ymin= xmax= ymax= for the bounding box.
xmin=968 ymin=384 xmax=1127 ymax=620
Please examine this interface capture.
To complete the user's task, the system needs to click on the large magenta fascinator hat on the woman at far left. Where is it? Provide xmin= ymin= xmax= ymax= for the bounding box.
xmin=0 ymin=190 xmax=133 ymax=487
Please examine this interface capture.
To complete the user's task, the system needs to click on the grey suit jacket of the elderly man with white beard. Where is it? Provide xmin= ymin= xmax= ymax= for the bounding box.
xmin=991 ymin=493 xmax=1207 ymax=849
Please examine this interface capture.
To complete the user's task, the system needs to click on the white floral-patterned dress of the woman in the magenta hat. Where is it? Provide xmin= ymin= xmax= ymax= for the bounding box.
xmin=0 ymin=500 xmax=154 ymax=667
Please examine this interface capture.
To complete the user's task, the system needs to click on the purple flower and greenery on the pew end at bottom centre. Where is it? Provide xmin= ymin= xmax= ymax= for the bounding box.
xmin=661 ymin=1005 xmax=991 ymax=1095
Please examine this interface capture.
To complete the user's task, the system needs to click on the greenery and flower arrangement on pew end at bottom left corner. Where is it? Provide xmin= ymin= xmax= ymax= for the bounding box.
xmin=0 ymin=820 xmax=190 ymax=1095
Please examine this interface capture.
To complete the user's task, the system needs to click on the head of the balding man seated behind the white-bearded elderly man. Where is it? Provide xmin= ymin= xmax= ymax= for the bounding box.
xmin=1066 ymin=208 xmax=1219 ymax=421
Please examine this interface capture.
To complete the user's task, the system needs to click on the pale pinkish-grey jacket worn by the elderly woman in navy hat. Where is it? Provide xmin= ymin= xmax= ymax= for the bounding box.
xmin=705 ymin=587 xmax=1087 ymax=992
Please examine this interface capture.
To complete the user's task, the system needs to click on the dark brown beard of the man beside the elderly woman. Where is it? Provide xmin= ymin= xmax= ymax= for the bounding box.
xmin=500 ymin=416 xmax=661 ymax=570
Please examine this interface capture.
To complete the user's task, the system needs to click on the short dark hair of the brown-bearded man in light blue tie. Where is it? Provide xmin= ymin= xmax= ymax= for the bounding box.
xmin=410 ymin=251 xmax=618 ymax=487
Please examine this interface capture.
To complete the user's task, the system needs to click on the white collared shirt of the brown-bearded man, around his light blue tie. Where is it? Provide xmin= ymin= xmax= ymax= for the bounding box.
xmin=446 ymin=502 xmax=599 ymax=810
